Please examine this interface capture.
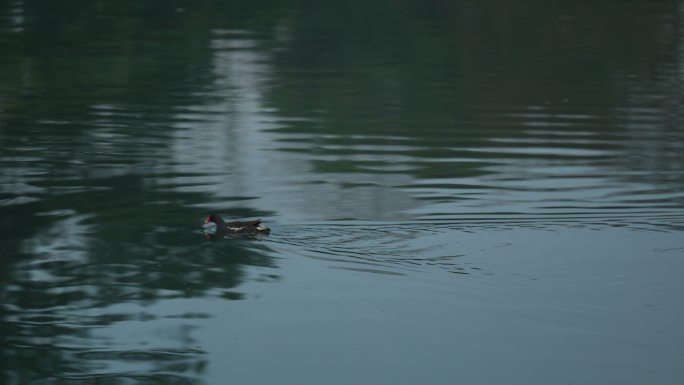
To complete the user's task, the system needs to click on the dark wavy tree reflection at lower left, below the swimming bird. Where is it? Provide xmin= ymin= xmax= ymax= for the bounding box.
xmin=1 ymin=177 xmax=275 ymax=383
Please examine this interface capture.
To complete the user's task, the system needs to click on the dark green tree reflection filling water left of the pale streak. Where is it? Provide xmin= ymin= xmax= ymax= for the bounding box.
xmin=0 ymin=0 xmax=288 ymax=384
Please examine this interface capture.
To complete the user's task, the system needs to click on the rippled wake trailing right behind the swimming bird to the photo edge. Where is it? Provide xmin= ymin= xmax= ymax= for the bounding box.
xmin=267 ymin=212 xmax=684 ymax=275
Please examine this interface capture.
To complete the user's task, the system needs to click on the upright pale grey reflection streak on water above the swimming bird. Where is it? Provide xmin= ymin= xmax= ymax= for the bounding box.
xmin=170 ymin=30 xmax=278 ymax=207
